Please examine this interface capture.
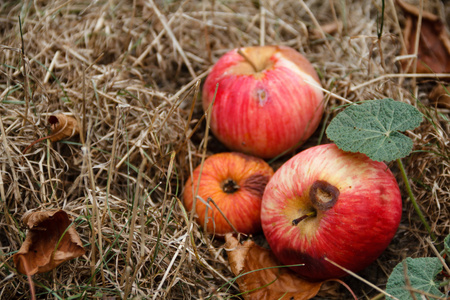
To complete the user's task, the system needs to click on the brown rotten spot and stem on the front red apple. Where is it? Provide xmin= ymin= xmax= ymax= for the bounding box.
xmin=292 ymin=180 xmax=340 ymax=226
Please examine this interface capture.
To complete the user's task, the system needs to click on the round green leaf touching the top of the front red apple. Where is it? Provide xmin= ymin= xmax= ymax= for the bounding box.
xmin=326 ymin=98 xmax=423 ymax=162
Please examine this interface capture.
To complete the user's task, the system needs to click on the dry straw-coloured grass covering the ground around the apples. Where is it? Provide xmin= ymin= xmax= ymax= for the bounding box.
xmin=0 ymin=0 xmax=450 ymax=299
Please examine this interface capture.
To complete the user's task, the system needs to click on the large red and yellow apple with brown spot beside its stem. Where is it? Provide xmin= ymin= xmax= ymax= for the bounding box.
xmin=261 ymin=144 xmax=402 ymax=281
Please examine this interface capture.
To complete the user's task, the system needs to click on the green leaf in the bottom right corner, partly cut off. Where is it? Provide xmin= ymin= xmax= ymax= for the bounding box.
xmin=386 ymin=257 xmax=444 ymax=300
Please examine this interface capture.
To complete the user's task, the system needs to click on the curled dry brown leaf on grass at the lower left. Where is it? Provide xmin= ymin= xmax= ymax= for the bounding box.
xmin=13 ymin=210 xmax=85 ymax=275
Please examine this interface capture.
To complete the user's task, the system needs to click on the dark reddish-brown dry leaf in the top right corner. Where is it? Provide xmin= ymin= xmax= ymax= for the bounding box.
xmin=396 ymin=0 xmax=450 ymax=73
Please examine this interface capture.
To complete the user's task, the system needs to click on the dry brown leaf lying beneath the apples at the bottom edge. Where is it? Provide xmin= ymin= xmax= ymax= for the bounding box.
xmin=225 ymin=234 xmax=322 ymax=300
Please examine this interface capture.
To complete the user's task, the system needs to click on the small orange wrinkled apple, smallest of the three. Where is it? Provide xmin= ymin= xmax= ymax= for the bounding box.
xmin=183 ymin=152 xmax=274 ymax=236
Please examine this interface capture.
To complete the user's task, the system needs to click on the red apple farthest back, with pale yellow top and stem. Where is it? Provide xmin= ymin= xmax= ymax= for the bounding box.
xmin=203 ymin=46 xmax=323 ymax=158
